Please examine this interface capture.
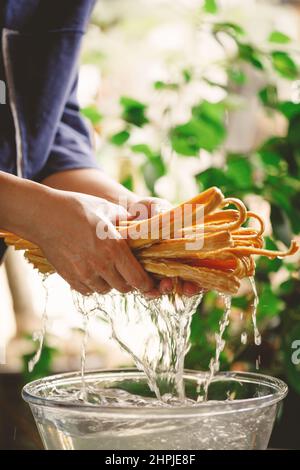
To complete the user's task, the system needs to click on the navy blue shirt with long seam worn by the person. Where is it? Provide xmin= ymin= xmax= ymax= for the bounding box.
xmin=0 ymin=0 xmax=98 ymax=256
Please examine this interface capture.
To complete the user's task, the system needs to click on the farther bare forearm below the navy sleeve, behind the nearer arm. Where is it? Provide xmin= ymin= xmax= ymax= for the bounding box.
xmin=42 ymin=169 xmax=138 ymax=207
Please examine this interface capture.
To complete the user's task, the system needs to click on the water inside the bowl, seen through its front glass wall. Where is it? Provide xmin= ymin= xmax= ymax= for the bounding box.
xmin=33 ymin=401 xmax=277 ymax=451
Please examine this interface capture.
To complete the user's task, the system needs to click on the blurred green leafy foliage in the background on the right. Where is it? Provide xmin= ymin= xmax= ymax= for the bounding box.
xmin=80 ymin=0 xmax=300 ymax=393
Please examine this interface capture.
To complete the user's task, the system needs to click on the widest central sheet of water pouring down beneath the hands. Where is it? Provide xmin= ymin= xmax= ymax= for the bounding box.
xmin=93 ymin=291 xmax=202 ymax=401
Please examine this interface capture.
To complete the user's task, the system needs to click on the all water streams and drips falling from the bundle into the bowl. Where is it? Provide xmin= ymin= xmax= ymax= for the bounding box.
xmin=29 ymin=278 xmax=261 ymax=405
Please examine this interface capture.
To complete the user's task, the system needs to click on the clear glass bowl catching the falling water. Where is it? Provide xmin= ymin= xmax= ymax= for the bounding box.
xmin=22 ymin=369 xmax=287 ymax=450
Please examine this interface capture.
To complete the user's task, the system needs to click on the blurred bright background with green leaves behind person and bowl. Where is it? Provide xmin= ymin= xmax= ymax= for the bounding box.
xmin=0 ymin=0 xmax=300 ymax=448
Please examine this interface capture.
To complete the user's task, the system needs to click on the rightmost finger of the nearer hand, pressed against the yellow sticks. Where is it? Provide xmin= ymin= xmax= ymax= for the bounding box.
xmin=115 ymin=239 xmax=153 ymax=292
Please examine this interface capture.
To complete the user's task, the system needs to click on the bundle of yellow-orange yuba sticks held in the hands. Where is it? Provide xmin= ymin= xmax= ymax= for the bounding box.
xmin=0 ymin=187 xmax=299 ymax=295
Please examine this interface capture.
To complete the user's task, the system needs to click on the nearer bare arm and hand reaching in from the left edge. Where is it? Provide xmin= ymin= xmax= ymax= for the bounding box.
xmin=0 ymin=172 xmax=153 ymax=294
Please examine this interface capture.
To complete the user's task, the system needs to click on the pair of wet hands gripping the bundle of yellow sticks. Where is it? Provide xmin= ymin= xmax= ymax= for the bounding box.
xmin=35 ymin=191 xmax=199 ymax=297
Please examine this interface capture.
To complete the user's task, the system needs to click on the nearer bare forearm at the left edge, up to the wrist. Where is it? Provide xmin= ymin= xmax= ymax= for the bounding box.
xmin=0 ymin=171 xmax=52 ymax=241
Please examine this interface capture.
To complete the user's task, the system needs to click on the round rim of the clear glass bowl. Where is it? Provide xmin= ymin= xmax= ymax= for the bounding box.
xmin=22 ymin=368 xmax=288 ymax=419
